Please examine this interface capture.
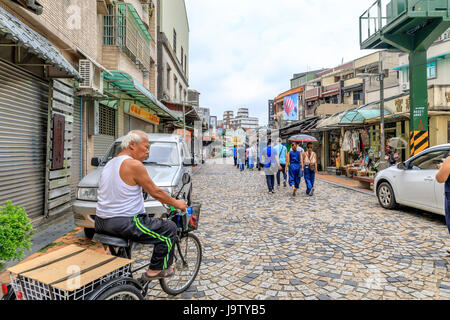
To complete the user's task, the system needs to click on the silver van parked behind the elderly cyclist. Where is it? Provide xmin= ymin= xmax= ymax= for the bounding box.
xmin=73 ymin=134 xmax=194 ymax=237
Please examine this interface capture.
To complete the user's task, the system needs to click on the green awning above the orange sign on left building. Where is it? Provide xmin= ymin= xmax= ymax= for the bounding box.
xmin=103 ymin=71 xmax=180 ymax=120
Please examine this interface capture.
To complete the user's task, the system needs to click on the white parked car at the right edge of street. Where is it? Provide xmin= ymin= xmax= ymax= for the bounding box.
xmin=374 ymin=144 xmax=450 ymax=215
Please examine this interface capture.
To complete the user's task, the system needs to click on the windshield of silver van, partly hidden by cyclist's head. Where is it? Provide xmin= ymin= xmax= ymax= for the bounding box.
xmin=102 ymin=142 xmax=180 ymax=166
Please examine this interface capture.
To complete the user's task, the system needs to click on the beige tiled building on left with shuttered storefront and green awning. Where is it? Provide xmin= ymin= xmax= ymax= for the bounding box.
xmin=0 ymin=0 xmax=180 ymax=225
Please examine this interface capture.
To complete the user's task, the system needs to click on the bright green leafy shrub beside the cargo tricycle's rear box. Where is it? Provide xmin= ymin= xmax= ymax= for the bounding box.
xmin=0 ymin=201 xmax=33 ymax=261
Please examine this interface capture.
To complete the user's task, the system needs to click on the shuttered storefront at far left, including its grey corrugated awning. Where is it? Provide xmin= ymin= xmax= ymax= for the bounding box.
xmin=0 ymin=7 xmax=80 ymax=225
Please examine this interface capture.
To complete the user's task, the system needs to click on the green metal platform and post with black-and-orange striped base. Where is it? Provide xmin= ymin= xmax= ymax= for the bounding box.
xmin=359 ymin=0 xmax=450 ymax=155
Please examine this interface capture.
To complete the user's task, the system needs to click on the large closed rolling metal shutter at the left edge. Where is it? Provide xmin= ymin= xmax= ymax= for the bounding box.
xmin=0 ymin=61 xmax=49 ymax=218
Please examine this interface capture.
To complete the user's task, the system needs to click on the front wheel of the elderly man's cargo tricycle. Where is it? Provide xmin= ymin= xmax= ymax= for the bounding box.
xmin=159 ymin=233 xmax=202 ymax=296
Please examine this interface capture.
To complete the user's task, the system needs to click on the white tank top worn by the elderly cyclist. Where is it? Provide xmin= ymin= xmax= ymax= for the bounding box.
xmin=97 ymin=156 xmax=145 ymax=219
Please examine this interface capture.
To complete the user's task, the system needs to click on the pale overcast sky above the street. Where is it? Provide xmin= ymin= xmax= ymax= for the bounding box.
xmin=185 ymin=0 xmax=374 ymax=125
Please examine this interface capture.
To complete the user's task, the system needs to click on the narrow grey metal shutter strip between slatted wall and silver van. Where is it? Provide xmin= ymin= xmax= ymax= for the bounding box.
xmin=70 ymin=97 xmax=83 ymax=199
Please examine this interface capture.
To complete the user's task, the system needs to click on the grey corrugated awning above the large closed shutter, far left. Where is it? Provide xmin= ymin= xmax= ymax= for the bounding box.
xmin=0 ymin=7 xmax=81 ymax=80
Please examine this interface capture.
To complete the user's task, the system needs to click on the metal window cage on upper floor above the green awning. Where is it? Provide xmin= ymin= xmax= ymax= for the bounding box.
xmin=103 ymin=3 xmax=151 ymax=72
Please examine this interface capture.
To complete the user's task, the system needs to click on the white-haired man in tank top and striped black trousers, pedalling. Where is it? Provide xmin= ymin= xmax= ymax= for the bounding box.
xmin=95 ymin=130 xmax=187 ymax=281
